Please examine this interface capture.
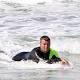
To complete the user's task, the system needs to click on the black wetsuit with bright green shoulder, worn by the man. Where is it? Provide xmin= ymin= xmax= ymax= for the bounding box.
xmin=12 ymin=47 xmax=60 ymax=63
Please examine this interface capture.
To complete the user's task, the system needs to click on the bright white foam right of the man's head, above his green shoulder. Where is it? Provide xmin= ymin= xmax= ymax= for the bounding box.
xmin=51 ymin=38 xmax=80 ymax=54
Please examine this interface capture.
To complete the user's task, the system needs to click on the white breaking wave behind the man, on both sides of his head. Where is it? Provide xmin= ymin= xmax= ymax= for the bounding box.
xmin=0 ymin=35 xmax=80 ymax=57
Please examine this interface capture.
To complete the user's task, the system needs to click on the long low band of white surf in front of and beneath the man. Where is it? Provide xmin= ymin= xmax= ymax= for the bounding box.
xmin=0 ymin=53 xmax=73 ymax=70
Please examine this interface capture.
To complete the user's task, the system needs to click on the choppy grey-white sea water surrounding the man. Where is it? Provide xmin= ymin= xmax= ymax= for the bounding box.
xmin=0 ymin=0 xmax=80 ymax=80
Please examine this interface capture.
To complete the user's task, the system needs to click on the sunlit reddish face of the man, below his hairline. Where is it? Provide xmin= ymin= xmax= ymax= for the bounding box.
xmin=40 ymin=39 xmax=50 ymax=53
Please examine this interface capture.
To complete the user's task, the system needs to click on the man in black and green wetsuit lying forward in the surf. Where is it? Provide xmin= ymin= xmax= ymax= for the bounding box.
xmin=13 ymin=36 xmax=67 ymax=64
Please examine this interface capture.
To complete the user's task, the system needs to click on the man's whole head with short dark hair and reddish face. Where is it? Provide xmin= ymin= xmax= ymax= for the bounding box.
xmin=40 ymin=36 xmax=50 ymax=53
